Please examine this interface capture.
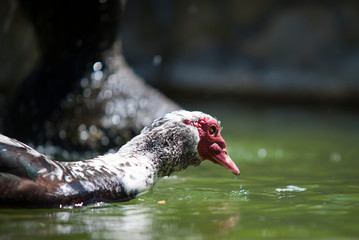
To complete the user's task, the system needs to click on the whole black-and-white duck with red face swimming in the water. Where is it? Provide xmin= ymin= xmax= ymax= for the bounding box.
xmin=0 ymin=110 xmax=240 ymax=208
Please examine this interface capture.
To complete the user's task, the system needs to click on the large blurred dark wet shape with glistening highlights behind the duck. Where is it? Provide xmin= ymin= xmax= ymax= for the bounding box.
xmin=2 ymin=1 xmax=178 ymax=158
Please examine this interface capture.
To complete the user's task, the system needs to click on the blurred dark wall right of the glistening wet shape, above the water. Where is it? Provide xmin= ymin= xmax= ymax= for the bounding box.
xmin=122 ymin=0 xmax=359 ymax=105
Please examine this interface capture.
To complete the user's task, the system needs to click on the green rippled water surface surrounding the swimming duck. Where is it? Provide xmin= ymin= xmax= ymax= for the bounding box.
xmin=0 ymin=104 xmax=359 ymax=240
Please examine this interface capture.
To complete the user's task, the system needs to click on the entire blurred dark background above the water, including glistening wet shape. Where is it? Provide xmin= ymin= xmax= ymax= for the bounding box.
xmin=0 ymin=0 xmax=359 ymax=152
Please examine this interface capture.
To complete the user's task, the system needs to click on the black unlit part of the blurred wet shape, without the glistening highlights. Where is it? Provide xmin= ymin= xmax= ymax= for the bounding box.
xmin=3 ymin=1 xmax=121 ymax=144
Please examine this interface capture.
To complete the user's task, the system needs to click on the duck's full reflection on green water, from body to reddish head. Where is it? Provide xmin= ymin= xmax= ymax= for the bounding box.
xmin=0 ymin=198 xmax=240 ymax=240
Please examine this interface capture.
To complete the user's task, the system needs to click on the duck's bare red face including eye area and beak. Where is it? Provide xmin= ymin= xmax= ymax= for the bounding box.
xmin=184 ymin=117 xmax=240 ymax=175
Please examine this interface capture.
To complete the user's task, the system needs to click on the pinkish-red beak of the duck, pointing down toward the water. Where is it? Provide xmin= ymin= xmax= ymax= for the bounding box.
xmin=209 ymin=144 xmax=240 ymax=175
